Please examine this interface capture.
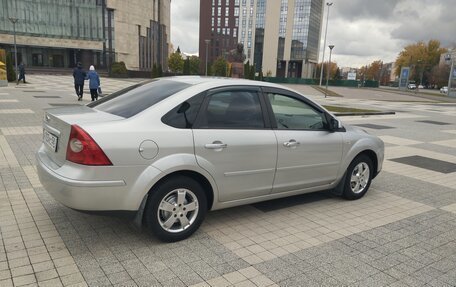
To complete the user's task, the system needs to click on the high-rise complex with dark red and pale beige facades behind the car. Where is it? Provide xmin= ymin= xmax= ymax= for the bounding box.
xmin=199 ymin=0 xmax=323 ymax=78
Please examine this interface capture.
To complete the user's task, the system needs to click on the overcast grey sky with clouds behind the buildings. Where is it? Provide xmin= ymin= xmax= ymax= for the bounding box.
xmin=171 ymin=0 xmax=456 ymax=67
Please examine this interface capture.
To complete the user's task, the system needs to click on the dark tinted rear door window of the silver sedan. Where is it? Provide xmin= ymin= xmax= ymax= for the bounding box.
xmin=200 ymin=90 xmax=264 ymax=129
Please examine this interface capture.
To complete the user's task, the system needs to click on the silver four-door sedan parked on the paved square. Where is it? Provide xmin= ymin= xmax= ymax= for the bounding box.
xmin=36 ymin=77 xmax=384 ymax=242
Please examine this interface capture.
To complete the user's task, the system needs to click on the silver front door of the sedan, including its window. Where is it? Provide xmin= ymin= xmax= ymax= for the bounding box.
xmin=265 ymin=89 xmax=343 ymax=193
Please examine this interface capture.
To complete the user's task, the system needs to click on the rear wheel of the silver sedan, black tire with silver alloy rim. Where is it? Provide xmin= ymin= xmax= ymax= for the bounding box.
xmin=144 ymin=176 xmax=207 ymax=242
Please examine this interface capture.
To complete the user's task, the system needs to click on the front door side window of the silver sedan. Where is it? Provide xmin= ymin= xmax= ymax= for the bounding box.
xmin=268 ymin=93 xmax=327 ymax=130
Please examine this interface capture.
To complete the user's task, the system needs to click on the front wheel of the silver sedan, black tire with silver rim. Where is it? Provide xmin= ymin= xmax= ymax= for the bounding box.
xmin=342 ymin=154 xmax=374 ymax=200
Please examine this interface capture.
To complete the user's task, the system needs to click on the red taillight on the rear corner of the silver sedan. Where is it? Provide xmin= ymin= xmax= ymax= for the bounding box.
xmin=66 ymin=125 xmax=112 ymax=165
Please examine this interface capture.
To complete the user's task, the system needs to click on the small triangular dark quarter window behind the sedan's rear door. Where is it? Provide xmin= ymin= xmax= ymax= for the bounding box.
xmin=162 ymin=94 xmax=204 ymax=129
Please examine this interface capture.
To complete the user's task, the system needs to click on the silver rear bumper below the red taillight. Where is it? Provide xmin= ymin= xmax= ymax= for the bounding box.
xmin=36 ymin=152 xmax=137 ymax=211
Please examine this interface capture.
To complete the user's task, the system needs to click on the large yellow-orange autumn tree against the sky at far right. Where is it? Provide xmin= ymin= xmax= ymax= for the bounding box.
xmin=395 ymin=40 xmax=447 ymax=84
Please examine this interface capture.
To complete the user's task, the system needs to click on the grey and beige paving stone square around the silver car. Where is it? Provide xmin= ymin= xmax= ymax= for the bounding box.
xmin=0 ymin=75 xmax=456 ymax=287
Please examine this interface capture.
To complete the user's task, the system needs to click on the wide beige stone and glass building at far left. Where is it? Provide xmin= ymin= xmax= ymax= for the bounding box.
xmin=0 ymin=0 xmax=171 ymax=71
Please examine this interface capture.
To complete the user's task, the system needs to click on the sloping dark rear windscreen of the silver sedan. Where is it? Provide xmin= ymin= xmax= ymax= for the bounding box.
xmin=87 ymin=79 xmax=190 ymax=118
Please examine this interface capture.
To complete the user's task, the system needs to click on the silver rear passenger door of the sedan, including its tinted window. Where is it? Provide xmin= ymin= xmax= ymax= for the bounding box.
xmin=193 ymin=87 xmax=277 ymax=202
